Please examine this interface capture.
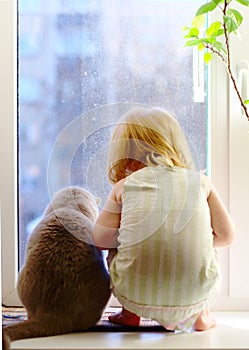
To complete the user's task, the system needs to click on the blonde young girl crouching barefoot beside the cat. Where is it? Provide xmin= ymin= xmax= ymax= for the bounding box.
xmin=93 ymin=108 xmax=234 ymax=331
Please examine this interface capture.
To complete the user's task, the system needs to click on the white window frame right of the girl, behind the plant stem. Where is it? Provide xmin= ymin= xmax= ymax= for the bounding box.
xmin=208 ymin=4 xmax=249 ymax=311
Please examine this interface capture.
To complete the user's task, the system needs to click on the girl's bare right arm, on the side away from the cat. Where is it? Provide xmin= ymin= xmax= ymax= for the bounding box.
xmin=203 ymin=174 xmax=235 ymax=247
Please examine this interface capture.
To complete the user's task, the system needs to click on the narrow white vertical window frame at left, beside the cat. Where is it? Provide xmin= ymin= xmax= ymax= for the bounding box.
xmin=0 ymin=0 xmax=19 ymax=305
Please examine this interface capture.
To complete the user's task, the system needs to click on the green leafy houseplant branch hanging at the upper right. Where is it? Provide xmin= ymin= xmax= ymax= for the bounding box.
xmin=183 ymin=0 xmax=249 ymax=121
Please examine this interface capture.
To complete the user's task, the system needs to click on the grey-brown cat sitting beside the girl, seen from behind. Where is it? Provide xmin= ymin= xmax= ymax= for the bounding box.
xmin=3 ymin=187 xmax=111 ymax=350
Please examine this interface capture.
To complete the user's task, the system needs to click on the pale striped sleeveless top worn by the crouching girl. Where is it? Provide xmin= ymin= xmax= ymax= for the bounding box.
xmin=110 ymin=166 xmax=219 ymax=330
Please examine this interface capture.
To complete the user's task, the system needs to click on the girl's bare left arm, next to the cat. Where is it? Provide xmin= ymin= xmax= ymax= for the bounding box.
xmin=93 ymin=179 xmax=125 ymax=249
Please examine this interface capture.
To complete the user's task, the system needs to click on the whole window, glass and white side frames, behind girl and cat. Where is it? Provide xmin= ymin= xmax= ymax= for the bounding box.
xmin=0 ymin=0 xmax=249 ymax=310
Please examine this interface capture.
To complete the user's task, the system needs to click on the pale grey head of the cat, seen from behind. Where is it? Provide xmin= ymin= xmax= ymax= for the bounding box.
xmin=45 ymin=186 xmax=99 ymax=221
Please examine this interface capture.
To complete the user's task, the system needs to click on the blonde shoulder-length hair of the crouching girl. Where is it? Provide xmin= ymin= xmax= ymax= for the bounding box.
xmin=108 ymin=107 xmax=194 ymax=183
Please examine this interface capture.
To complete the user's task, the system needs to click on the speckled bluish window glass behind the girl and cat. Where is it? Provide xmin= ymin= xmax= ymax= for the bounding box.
xmin=18 ymin=0 xmax=207 ymax=266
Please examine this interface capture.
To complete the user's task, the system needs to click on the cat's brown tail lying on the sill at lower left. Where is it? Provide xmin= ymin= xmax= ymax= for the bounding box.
xmin=2 ymin=319 xmax=70 ymax=350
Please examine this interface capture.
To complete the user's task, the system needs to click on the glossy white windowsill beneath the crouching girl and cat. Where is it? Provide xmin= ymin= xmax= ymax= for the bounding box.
xmin=12 ymin=312 xmax=249 ymax=350
